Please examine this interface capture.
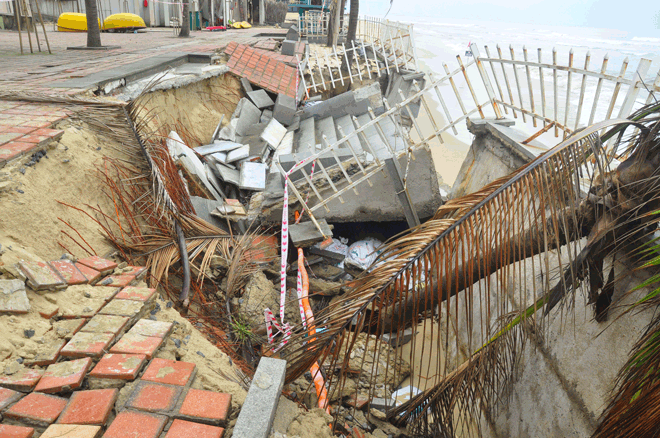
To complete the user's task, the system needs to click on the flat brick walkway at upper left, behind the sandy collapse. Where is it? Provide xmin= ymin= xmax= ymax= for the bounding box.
xmin=0 ymin=26 xmax=286 ymax=168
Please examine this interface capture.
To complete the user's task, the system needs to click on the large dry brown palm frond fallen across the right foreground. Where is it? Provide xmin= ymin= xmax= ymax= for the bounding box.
xmin=285 ymin=103 xmax=660 ymax=436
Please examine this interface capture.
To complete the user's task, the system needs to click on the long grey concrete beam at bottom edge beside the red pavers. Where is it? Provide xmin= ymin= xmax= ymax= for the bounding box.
xmin=232 ymin=357 xmax=286 ymax=438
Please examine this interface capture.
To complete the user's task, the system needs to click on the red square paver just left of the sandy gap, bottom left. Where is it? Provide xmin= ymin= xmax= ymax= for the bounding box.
xmin=57 ymin=388 xmax=119 ymax=426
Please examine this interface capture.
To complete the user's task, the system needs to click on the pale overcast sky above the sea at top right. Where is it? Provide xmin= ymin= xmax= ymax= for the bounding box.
xmin=360 ymin=0 xmax=660 ymax=38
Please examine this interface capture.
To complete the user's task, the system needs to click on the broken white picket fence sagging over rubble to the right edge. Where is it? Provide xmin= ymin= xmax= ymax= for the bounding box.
xmin=278 ymin=42 xmax=660 ymax=236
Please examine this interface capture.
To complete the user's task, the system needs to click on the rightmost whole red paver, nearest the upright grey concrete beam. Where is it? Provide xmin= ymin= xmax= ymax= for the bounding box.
xmin=175 ymin=388 xmax=231 ymax=426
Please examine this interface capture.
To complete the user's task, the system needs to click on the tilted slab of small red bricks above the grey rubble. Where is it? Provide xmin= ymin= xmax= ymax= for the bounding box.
xmin=225 ymin=43 xmax=298 ymax=98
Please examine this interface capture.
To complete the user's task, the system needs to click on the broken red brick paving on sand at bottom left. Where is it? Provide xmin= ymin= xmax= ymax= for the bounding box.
xmin=0 ymin=257 xmax=231 ymax=438
